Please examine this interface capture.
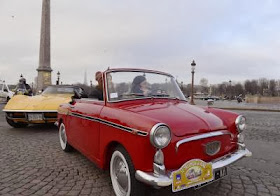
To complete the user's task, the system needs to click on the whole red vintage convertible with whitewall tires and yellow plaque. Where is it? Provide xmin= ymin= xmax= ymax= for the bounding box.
xmin=57 ymin=69 xmax=251 ymax=195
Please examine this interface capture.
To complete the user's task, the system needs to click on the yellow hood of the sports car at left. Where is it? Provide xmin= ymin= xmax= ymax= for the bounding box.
xmin=3 ymin=94 xmax=72 ymax=111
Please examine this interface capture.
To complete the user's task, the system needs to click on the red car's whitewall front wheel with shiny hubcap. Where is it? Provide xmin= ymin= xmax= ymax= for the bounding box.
xmin=110 ymin=146 xmax=146 ymax=196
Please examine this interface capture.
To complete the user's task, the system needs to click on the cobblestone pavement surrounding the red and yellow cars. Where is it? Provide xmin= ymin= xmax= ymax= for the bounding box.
xmin=0 ymin=105 xmax=280 ymax=196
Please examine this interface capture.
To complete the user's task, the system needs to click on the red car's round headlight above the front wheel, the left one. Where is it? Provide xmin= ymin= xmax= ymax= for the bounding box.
xmin=150 ymin=123 xmax=171 ymax=149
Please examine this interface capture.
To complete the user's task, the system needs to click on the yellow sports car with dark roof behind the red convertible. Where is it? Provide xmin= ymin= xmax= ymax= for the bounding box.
xmin=3 ymin=85 xmax=86 ymax=128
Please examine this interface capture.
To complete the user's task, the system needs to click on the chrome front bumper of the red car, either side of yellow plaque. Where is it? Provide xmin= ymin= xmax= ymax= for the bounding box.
xmin=135 ymin=148 xmax=252 ymax=187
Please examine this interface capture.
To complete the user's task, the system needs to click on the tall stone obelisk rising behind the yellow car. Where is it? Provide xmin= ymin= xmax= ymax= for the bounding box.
xmin=37 ymin=0 xmax=52 ymax=92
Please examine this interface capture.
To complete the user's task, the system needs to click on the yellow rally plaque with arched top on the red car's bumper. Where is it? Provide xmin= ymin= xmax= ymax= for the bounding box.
xmin=171 ymin=159 xmax=214 ymax=192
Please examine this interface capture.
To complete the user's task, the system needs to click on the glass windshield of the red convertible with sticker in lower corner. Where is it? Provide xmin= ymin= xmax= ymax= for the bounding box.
xmin=106 ymin=71 xmax=186 ymax=101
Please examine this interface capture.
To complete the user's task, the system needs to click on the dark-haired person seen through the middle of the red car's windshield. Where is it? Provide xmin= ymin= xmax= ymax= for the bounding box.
xmin=131 ymin=76 xmax=150 ymax=96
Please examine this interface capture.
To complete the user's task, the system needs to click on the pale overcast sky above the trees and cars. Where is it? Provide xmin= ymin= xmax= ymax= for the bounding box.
xmin=0 ymin=0 xmax=280 ymax=84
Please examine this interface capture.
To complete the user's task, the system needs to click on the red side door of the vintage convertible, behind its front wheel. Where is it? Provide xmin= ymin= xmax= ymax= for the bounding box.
xmin=69 ymin=99 xmax=104 ymax=161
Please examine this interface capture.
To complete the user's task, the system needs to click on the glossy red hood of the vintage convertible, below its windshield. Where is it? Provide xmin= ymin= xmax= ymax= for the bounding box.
xmin=121 ymin=101 xmax=226 ymax=137
